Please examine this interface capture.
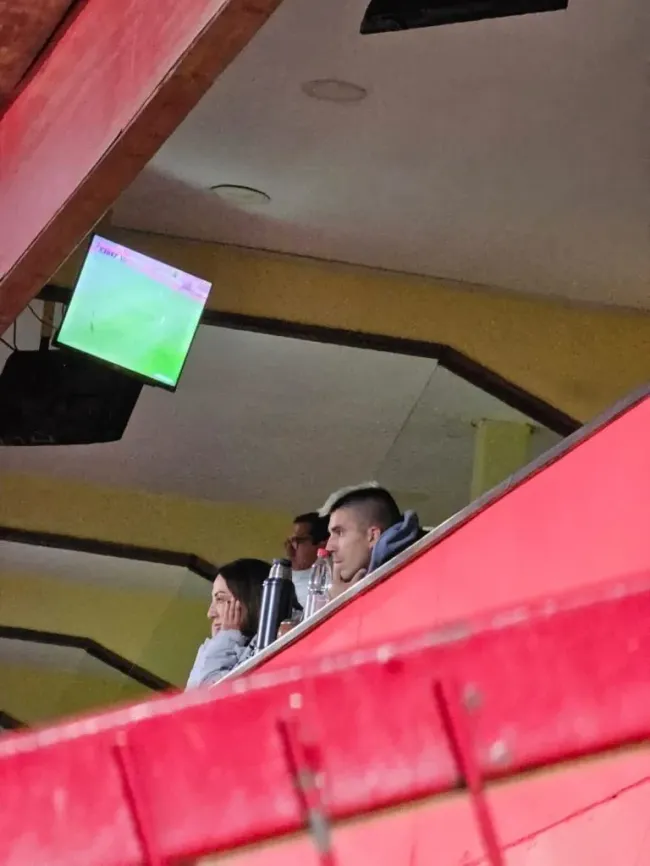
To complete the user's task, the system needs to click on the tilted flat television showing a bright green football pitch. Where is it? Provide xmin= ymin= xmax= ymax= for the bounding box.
xmin=55 ymin=235 xmax=210 ymax=391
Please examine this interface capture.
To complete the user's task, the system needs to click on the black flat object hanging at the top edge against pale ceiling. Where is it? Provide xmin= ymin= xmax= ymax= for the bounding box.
xmin=361 ymin=0 xmax=569 ymax=34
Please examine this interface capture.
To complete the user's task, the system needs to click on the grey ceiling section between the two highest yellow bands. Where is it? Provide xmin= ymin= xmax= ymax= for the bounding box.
xmin=0 ymin=311 xmax=557 ymax=528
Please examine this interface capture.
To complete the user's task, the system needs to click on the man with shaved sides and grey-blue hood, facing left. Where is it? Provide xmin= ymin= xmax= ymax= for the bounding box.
xmin=321 ymin=482 xmax=424 ymax=597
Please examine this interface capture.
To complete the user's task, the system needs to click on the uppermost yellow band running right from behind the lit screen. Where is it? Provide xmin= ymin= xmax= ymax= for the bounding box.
xmin=54 ymin=229 xmax=650 ymax=421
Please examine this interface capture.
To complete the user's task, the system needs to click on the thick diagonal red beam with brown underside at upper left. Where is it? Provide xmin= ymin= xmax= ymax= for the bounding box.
xmin=0 ymin=0 xmax=281 ymax=333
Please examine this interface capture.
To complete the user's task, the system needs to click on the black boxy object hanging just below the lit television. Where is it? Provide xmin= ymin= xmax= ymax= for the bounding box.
xmin=0 ymin=350 xmax=142 ymax=445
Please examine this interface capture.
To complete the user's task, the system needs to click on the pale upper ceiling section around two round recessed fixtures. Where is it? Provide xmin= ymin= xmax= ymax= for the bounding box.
xmin=114 ymin=0 xmax=650 ymax=308
